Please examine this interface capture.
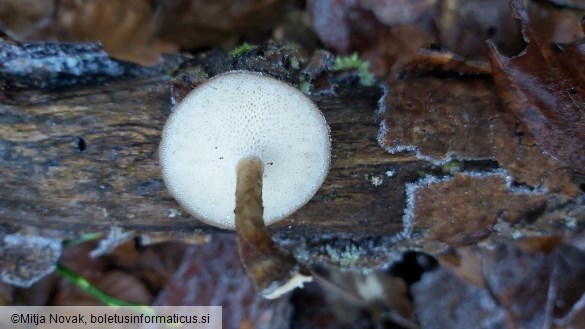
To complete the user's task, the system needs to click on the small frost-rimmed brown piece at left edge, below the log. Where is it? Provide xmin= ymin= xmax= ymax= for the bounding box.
xmin=0 ymin=233 xmax=62 ymax=288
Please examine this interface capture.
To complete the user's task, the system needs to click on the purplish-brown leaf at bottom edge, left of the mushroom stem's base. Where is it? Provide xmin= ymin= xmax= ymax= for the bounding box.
xmin=154 ymin=234 xmax=290 ymax=329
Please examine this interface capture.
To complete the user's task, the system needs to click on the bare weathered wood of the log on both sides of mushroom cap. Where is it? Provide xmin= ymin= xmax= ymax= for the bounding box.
xmin=0 ymin=73 xmax=428 ymax=235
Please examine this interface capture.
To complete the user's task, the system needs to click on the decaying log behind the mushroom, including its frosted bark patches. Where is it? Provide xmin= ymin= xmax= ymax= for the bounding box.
xmin=0 ymin=41 xmax=581 ymax=249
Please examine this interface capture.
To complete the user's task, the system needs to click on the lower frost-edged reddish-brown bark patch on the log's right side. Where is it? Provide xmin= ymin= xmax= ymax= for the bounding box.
xmin=403 ymin=171 xmax=547 ymax=246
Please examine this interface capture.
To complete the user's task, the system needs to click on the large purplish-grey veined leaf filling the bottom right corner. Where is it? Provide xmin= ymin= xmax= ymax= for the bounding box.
xmin=413 ymin=233 xmax=585 ymax=328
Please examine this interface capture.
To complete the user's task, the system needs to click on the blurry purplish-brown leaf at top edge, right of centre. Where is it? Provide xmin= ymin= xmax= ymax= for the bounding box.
xmin=307 ymin=0 xmax=437 ymax=76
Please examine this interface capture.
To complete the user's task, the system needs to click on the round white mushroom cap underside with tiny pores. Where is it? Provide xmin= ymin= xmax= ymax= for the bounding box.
xmin=160 ymin=72 xmax=331 ymax=229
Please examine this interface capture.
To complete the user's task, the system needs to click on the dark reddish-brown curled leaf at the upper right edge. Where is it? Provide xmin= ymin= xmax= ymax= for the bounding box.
xmin=488 ymin=0 xmax=585 ymax=173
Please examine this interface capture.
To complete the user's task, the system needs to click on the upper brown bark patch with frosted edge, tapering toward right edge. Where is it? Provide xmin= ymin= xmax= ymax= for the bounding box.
xmin=378 ymin=78 xmax=581 ymax=197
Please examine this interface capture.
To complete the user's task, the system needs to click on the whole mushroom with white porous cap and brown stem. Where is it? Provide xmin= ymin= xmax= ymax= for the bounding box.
xmin=160 ymin=71 xmax=331 ymax=298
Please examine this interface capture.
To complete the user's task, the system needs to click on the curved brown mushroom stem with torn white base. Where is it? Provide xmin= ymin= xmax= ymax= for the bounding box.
xmin=235 ymin=156 xmax=312 ymax=299
